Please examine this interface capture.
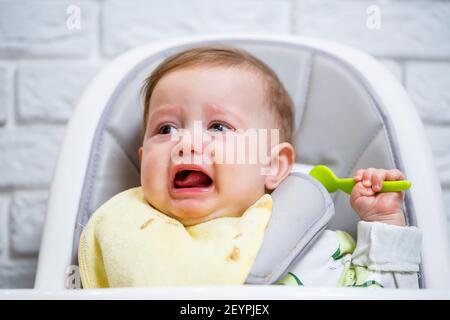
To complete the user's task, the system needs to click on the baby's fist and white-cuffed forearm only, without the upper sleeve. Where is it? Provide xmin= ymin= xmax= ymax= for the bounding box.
xmin=350 ymin=168 xmax=421 ymax=287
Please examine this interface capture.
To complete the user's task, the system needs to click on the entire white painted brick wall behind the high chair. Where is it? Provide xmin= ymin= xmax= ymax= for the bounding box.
xmin=0 ymin=0 xmax=450 ymax=288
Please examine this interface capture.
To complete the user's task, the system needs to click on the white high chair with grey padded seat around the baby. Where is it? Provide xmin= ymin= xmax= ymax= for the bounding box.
xmin=4 ymin=34 xmax=450 ymax=299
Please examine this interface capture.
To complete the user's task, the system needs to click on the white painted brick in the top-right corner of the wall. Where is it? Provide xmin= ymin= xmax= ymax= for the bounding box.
xmin=295 ymin=0 xmax=450 ymax=59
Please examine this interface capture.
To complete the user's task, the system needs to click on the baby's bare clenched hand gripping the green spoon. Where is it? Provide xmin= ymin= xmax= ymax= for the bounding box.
xmin=350 ymin=168 xmax=405 ymax=226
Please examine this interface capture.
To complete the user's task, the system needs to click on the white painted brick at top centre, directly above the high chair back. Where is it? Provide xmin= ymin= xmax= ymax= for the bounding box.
xmin=101 ymin=0 xmax=292 ymax=56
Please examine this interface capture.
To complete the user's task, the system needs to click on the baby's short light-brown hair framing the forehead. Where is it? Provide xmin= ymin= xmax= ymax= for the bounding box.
xmin=141 ymin=45 xmax=294 ymax=142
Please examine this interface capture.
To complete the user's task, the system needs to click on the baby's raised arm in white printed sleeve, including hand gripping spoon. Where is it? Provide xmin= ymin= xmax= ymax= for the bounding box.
xmin=279 ymin=168 xmax=422 ymax=288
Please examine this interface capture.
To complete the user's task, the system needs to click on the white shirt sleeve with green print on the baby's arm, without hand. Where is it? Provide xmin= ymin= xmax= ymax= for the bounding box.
xmin=278 ymin=221 xmax=422 ymax=288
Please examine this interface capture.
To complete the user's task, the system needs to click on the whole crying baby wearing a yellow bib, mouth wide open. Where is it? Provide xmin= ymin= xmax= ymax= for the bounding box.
xmin=79 ymin=46 xmax=420 ymax=288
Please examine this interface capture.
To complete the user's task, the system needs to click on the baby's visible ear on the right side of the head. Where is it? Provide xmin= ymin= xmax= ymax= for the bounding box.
xmin=265 ymin=142 xmax=295 ymax=190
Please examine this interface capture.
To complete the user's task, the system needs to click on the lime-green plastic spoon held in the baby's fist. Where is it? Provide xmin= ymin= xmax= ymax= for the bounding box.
xmin=309 ymin=165 xmax=411 ymax=194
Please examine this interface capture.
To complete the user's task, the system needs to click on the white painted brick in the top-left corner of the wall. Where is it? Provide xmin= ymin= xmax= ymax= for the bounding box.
xmin=0 ymin=0 xmax=98 ymax=58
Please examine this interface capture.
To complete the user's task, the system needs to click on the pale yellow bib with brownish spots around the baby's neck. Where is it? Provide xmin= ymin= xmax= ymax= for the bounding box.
xmin=78 ymin=187 xmax=272 ymax=288
